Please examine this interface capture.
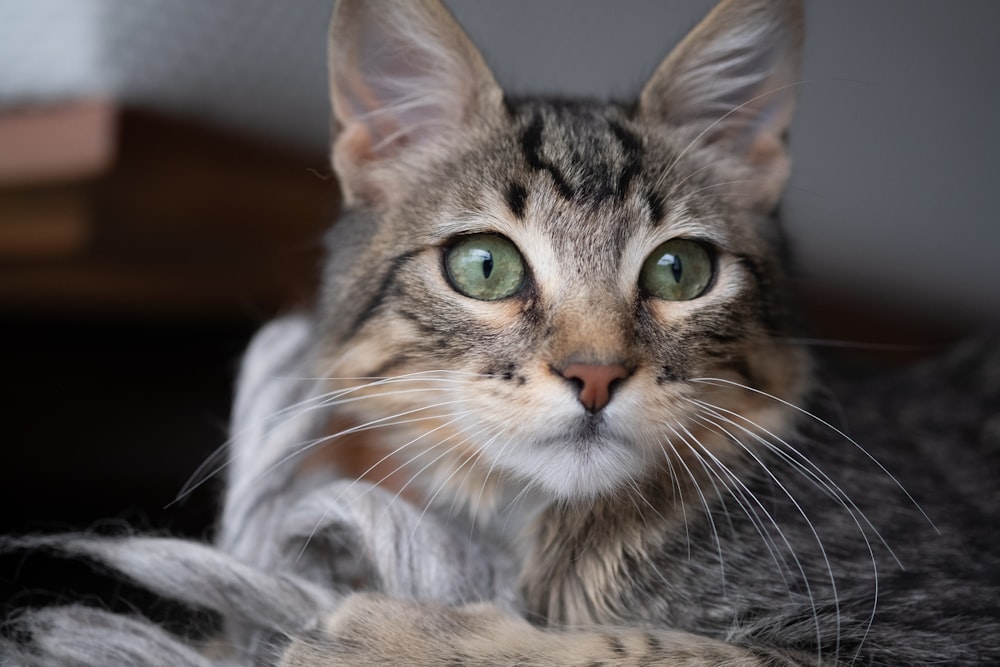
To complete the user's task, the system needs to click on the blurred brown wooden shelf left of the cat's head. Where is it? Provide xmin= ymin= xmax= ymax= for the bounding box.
xmin=0 ymin=102 xmax=337 ymax=320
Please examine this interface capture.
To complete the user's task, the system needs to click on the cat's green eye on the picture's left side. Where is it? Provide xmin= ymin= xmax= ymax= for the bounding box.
xmin=444 ymin=234 xmax=524 ymax=301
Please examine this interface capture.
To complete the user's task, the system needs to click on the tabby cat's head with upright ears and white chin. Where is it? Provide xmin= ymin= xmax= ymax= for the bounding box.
xmin=321 ymin=0 xmax=808 ymax=508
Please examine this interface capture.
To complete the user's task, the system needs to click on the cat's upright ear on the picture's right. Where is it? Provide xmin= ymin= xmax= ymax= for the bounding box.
xmin=639 ymin=0 xmax=805 ymax=207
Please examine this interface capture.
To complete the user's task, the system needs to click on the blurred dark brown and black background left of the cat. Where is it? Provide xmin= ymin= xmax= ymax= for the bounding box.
xmin=0 ymin=108 xmax=337 ymax=618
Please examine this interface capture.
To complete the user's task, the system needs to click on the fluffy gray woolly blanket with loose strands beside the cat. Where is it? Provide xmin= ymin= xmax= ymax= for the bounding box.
xmin=0 ymin=316 xmax=516 ymax=667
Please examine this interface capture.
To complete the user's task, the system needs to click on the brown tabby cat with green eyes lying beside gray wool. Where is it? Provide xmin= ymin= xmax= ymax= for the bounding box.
xmin=270 ymin=0 xmax=1000 ymax=667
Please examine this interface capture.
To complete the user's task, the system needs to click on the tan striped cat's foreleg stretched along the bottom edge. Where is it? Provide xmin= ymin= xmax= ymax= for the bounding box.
xmin=280 ymin=594 xmax=817 ymax=667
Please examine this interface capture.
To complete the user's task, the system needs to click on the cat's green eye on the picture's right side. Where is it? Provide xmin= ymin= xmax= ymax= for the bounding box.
xmin=639 ymin=239 xmax=713 ymax=301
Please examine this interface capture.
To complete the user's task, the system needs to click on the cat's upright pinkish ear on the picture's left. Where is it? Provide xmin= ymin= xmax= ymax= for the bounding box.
xmin=328 ymin=0 xmax=503 ymax=201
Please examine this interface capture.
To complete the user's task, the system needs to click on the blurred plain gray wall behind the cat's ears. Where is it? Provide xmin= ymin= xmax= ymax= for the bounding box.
xmin=0 ymin=0 xmax=1000 ymax=319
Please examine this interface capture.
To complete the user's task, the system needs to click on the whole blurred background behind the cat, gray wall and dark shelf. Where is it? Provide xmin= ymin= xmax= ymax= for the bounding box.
xmin=0 ymin=0 xmax=1000 ymax=620
